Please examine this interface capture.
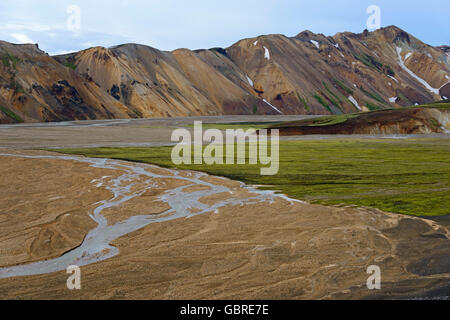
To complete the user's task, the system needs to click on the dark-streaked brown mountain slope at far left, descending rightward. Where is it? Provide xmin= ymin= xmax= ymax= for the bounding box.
xmin=0 ymin=42 xmax=131 ymax=123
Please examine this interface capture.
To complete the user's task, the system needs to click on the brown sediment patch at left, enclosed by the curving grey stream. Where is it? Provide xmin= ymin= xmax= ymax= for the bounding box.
xmin=0 ymin=152 xmax=117 ymax=266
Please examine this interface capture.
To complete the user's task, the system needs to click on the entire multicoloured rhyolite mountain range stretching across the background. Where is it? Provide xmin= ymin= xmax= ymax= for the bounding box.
xmin=0 ymin=26 xmax=450 ymax=123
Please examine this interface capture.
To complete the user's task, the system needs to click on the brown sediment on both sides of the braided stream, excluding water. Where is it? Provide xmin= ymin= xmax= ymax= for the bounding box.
xmin=0 ymin=152 xmax=450 ymax=299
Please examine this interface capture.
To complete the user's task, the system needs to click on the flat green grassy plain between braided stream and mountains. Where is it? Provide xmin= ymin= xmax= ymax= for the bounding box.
xmin=56 ymin=139 xmax=450 ymax=216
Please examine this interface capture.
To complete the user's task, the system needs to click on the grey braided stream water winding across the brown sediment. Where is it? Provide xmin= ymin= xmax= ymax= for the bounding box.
xmin=0 ymin=154 xmax=296 ymax=279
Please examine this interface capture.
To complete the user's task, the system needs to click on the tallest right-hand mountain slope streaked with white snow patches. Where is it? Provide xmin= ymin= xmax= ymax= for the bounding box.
xmin=227 ymin=27 xmax=450 ymax=113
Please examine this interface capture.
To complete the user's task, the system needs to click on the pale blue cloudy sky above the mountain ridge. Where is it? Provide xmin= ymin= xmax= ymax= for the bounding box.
xmin=0 ymin=0 xmax=450 ymax=54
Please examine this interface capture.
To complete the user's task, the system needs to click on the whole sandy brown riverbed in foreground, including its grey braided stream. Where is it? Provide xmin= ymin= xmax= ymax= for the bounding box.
xmin=0 ymin=149 xmax=450 ymax=299
